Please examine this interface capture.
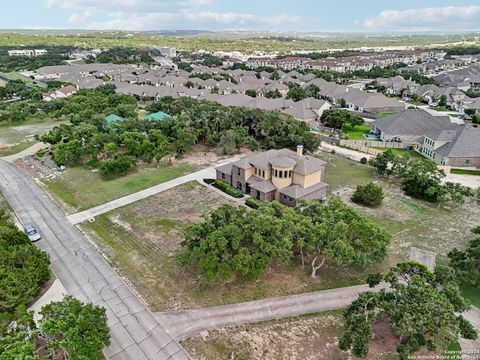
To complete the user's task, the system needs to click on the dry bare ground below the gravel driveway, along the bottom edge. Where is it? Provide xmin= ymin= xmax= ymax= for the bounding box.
xmin=182 ymin=311 xmax=440 ymax=360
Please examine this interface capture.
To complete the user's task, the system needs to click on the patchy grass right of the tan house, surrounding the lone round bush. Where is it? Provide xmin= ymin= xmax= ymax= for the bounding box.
xmin=318 ymin=153 xmax=480 ymax=265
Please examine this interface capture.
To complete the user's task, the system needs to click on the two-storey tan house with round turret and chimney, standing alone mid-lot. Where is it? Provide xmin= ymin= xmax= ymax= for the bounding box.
xmin=216 ymin=145 xmax=327 ymax=206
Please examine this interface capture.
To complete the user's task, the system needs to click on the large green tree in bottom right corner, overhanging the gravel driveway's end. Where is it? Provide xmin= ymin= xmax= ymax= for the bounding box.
xmin=339 ymin=262 xmax=477 ymax=360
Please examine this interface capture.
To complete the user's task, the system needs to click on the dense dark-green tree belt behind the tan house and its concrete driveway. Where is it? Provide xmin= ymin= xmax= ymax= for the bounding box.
xmin=35 ymin=85 xmax=319 ymax=176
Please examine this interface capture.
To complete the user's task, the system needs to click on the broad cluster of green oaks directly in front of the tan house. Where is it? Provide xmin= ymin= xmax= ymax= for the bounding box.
xmin=181 ymin=198 xmax=390 ymax=279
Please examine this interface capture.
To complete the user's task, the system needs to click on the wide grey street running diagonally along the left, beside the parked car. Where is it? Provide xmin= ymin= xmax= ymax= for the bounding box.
xmin=0 ymin=160 xmax=189 ymax=360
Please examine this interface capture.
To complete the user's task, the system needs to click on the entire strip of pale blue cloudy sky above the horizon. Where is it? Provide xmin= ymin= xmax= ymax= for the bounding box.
xmin=0 ymin=0 xmax=480 ymax=32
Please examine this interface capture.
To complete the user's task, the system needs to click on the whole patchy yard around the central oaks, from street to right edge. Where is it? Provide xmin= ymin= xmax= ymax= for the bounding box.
xmin=82 ymin=153 xmax=480 ymax=311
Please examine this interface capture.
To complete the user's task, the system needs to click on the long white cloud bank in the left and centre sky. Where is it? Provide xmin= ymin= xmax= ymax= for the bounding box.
xmin=43 ymin=0 xmax=302 ymax=31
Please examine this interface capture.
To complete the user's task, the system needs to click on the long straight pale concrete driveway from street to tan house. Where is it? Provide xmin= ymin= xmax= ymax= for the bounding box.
xmin=67 ymin=166 xmax=215 ymax=225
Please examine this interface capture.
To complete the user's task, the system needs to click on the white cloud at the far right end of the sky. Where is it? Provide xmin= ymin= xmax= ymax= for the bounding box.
xmin=363 ymin=6 xmax=480 ymax=31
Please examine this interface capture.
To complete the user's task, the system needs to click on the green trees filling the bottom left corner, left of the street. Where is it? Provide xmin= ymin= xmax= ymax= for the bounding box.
xmin=0 ymin=209 xmax=110 ymax=360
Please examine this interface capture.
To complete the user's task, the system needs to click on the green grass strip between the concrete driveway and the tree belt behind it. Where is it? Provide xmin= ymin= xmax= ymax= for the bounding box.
xmin=45 ymin=163 xmax=198 ymax=211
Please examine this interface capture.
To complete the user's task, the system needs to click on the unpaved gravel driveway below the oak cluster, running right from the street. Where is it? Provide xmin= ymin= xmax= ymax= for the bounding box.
xmin=155 ymin=285 xmax=386 ymax=340
